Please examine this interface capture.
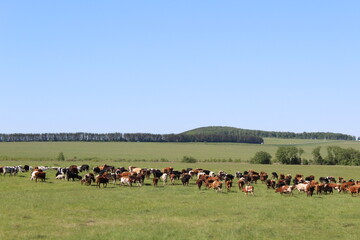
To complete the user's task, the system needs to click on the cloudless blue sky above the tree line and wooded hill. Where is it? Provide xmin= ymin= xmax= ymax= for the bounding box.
xmin=0 ymin=0 xmax=360 ymax=136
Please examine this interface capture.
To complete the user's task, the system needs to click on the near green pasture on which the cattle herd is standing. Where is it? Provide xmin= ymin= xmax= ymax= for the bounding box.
xmin=0 ymin=161 xmax=360 ymax=240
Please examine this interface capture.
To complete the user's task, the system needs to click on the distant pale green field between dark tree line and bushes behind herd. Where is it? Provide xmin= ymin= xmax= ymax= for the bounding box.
xmin=0 ymin=138 xmax=360 ymax=162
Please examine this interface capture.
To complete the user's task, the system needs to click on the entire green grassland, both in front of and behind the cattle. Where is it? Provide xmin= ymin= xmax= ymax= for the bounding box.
xmin=0 ymin=139 xmax=360 ymax=240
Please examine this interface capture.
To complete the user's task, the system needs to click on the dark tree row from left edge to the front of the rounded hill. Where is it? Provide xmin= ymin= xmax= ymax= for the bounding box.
xmin=0 ymin=133 xmax=264 ymax=144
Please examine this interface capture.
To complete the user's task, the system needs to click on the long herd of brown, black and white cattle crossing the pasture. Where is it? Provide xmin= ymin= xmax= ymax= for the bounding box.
xmin=0 ymin=164 xmax=360 ymax=197
